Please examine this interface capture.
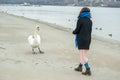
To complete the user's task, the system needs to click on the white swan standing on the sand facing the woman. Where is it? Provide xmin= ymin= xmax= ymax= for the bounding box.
xmin=28 ymin=25 xmax=44 ymax=54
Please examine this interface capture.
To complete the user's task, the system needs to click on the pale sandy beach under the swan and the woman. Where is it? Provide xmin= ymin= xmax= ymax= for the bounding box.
xmin=0 ymin=13 xmax=120 ymax=80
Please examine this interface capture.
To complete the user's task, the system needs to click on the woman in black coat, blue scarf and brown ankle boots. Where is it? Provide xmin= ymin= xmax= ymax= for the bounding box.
xmin=73 ymin=7 xmax=92 ymax=75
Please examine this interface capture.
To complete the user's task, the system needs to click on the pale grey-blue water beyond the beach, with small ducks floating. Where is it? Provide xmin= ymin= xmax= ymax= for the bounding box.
xmin=0 ymin=5 xmax=120 ymax=41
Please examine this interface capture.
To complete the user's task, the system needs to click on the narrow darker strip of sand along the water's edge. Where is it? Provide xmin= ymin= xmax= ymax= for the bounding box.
xmin=3 ymin=13 xmax=120 ymax=46
